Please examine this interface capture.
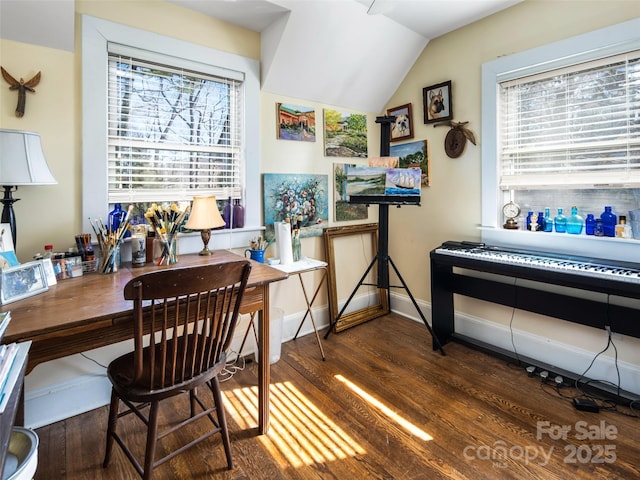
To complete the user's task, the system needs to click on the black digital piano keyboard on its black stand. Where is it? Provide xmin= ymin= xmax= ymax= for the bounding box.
xmin=430 ymin=241 xmax=640 ymax=345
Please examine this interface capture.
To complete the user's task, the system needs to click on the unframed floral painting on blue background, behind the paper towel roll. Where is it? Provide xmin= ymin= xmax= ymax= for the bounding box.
xmin=263 ymin=173 xmax=329 ymax=239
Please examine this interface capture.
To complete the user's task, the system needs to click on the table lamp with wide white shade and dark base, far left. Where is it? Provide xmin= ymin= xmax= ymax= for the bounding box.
xmin=0 ymin=129 xmax=58 ymax=249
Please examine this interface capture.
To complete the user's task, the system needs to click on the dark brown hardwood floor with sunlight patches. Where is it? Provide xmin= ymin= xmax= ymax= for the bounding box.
xmin=35 ymin=314 xmax=640 ymax=480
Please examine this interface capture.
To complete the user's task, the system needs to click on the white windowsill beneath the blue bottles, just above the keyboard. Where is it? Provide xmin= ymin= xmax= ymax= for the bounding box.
xmin=479 ymin=227 xmax=640 ymax=263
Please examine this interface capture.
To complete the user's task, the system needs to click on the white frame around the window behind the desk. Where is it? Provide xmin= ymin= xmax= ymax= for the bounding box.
xmin=82 ymin=15 xmax=261 ymax=237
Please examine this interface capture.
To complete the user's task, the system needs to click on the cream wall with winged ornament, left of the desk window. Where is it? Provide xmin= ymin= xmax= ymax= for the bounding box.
xmin=0 ymin=40 xmax=75 ymax=262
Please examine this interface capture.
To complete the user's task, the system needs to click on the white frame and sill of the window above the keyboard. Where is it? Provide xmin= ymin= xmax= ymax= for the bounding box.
xmin=480 ymin=19 xmax=640 ymax=262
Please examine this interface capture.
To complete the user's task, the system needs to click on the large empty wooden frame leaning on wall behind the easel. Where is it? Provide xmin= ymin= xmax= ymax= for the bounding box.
xmin=324 ymin=223 xmax=391 ymax=333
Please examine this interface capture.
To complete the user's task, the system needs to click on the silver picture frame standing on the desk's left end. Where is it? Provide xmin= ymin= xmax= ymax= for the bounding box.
xmin=0 ymin=260 xmax=49 ymax=305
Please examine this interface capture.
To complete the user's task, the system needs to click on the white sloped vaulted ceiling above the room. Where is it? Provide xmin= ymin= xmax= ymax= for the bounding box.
xmin=0 ymin=0 xmax=522 ymax=113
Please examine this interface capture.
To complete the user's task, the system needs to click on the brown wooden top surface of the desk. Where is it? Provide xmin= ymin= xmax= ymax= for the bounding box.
xmin=0 ymin=250 xmax=288 ymax=342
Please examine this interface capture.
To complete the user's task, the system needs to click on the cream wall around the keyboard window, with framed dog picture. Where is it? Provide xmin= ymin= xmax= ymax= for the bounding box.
xmin=388 ymin=0 xmax=640 ymax=378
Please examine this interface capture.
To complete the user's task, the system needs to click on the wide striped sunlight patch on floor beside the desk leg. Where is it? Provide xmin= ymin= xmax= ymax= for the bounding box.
xmin=224 ymin=382 xmax=366 ymax=467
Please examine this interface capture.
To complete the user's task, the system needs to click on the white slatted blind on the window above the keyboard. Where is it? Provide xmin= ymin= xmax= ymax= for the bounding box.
xmin=498 ymin=51 xmax=640 ymax=190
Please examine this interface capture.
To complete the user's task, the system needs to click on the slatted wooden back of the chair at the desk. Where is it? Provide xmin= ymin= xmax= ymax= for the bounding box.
xmin=124 ymin=260 xmax=251 ymax=390
